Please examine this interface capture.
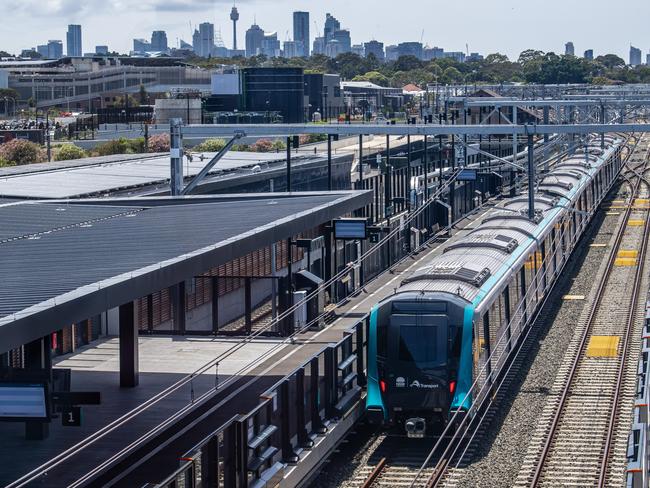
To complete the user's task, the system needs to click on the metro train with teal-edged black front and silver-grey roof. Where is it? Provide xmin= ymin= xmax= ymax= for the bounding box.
xmin=365 ymin=137 xmax=625 ymax=437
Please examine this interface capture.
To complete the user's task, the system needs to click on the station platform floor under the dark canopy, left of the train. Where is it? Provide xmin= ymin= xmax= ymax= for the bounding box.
xmin=0 ymin=196 xmax=492 ymax=487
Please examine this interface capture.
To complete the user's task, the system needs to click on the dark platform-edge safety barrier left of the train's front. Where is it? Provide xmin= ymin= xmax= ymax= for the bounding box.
xmin=146 ymin=316 xmax=369 ymax=488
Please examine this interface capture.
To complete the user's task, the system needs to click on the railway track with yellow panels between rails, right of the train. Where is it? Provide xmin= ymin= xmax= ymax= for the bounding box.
xmin=515 ymin=138 xmax=650 ymax=487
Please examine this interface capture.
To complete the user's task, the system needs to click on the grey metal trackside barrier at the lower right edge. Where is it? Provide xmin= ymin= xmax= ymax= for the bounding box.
xmin=626 ymin=301 xmax=650 ymax=488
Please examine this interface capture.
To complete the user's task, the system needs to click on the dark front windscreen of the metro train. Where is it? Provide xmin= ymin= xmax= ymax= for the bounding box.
xmin=399 ymin=324 xmax=447 ymax=368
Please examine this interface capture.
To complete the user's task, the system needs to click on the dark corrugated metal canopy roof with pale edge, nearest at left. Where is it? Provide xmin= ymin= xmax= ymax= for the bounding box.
xmin=0 ymin=191 xmax=372 ymax=353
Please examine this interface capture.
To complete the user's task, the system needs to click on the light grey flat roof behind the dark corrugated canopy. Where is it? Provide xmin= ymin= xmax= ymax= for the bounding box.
xmin=0 ymin=151 xmax=325 ymax=199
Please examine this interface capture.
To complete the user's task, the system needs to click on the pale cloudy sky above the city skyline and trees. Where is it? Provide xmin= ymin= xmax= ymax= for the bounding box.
xmin=0 ymin=0 xmax=650 ymax=60
